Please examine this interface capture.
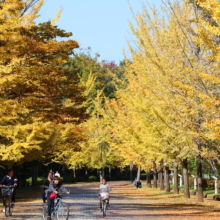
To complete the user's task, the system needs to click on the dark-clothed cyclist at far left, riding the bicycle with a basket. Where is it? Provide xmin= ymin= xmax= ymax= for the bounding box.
xmin=0 ymin=169 xmax=18 ymax=212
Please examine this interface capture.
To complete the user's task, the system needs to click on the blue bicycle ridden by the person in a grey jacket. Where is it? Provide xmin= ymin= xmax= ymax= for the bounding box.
xmin=43 ymin=193 xmax=69 ymax=220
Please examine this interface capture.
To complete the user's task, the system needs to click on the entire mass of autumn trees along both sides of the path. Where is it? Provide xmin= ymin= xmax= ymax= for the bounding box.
xmin=0 ymin=0 xmax=220 ymax=201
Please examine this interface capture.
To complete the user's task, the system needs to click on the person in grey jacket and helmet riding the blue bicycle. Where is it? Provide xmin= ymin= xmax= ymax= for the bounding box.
xmin=46 ymin=174 xmax=69 ymax=220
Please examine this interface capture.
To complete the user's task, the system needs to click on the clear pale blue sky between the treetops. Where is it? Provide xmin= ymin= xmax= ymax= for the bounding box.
xmin=37 ymin=0 xmax=161 ymax=63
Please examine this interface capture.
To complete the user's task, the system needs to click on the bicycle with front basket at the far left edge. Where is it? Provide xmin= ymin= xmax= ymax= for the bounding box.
xmin=2 ymin=185 xmax=16 ymax=217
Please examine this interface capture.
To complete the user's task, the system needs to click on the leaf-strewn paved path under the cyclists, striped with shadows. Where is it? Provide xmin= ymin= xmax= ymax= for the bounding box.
xmin=0 ymin=184 xmax=219 ymax=220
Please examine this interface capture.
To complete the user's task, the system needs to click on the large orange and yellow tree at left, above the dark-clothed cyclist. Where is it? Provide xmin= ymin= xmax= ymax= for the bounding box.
xmin=0 ymin=0 xmax=87 ymax=165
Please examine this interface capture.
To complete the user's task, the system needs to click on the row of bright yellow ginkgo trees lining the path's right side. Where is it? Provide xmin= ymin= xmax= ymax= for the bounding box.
xmin=65 ymin=0 xmax=220 ymax=201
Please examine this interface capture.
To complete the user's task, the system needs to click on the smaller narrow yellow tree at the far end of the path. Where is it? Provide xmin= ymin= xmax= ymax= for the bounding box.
xmin=64 ymin=74 xmax=123 ymax=180
